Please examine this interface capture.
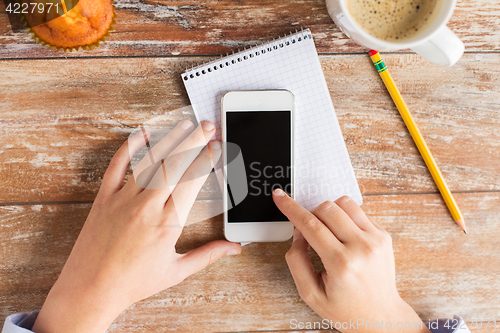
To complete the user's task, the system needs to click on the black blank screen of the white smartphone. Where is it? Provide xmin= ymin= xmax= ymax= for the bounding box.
xmin=225 ymin=111 xmax=293 ymax=223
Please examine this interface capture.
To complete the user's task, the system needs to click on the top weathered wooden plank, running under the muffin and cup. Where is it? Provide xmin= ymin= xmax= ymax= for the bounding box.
xmin=0 ymin=0 xmax=500 ymax=58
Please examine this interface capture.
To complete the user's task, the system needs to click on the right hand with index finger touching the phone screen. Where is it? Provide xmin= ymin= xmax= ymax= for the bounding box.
xmin=273 ymin=189 xmax=430 ymax=332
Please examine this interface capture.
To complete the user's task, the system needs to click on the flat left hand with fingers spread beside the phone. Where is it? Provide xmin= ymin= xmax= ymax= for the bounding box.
xmin=32 ymin=120 xmax=241 ymax=333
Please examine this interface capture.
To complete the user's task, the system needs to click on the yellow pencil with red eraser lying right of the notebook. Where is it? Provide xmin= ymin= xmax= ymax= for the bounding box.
xmin=369 ymin=50 xmax=467 ymax=233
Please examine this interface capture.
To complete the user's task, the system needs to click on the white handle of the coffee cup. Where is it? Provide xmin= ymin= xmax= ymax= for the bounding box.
xmin=412 ymin=26 xmax=464 ymax=66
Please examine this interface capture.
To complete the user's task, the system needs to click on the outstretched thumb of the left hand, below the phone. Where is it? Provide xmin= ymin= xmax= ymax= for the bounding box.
xmin=177 ymin=240 xmax=241 ymax=279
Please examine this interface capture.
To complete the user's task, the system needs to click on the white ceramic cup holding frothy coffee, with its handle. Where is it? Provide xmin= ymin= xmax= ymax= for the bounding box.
xmin=326 ymin=0 xmax=464 ymax=66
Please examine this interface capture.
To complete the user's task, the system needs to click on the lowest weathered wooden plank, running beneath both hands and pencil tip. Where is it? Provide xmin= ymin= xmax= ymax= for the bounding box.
xmin=0 ymin=192 xmax=500 ymax=332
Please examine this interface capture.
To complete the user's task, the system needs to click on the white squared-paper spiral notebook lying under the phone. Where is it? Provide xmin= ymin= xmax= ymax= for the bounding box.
xmin=182 ymin=29 xmax=362 ymax=209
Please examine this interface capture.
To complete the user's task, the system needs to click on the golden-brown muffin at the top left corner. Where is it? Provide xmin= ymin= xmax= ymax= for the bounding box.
xmin=24 ymin=0 xmax=115 ymax=51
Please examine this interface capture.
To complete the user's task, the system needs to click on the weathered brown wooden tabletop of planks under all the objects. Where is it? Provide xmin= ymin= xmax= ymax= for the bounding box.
xmin=0 ymin=0 xmax=500 ymax=332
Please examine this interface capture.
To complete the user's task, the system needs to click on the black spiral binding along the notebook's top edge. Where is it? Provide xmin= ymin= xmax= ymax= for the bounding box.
xmin=182 ymin=29 xmax=312 ymax=81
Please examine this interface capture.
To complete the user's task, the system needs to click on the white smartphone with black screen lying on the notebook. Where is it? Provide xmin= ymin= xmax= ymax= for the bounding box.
xmin=221 ymin=90 xmax=294 ymax=242
